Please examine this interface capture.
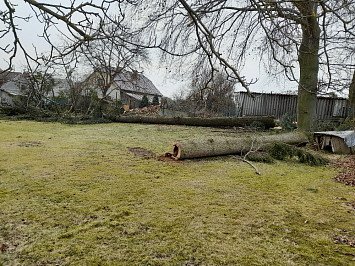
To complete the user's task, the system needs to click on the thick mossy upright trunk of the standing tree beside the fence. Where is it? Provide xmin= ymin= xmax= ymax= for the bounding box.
xmin=297 ymin=1 xmax=320 ymax=132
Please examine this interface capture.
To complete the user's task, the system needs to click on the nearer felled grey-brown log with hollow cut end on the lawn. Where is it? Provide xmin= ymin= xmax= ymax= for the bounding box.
xmin=172 ymin=132 xmax=308 ymax=160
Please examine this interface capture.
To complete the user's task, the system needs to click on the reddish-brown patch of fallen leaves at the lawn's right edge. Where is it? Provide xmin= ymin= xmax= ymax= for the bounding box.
xmin=332 ymin=155 xmax=355 ymax=187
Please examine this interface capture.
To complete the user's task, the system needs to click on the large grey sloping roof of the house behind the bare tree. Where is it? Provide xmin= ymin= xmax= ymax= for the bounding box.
xmin=114 ymin=70 xmax=163 ymax=96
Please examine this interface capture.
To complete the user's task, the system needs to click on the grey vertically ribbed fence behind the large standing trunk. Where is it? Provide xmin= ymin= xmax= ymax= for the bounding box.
xmin=235 ymin=92 xmax=348 ymax=120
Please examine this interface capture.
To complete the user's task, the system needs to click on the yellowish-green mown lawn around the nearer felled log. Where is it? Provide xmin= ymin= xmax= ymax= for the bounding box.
xmin=0 ymin=120 xmax=355 ymax=265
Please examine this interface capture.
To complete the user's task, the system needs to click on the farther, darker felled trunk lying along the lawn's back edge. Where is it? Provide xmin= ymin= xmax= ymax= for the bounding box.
xmin=113 ymin=116 xmax=275 ymax=128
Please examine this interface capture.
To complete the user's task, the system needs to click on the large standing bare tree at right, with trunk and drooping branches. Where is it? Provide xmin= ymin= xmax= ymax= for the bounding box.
xmin=139 ymin=0 xmax=355 ymax=131
